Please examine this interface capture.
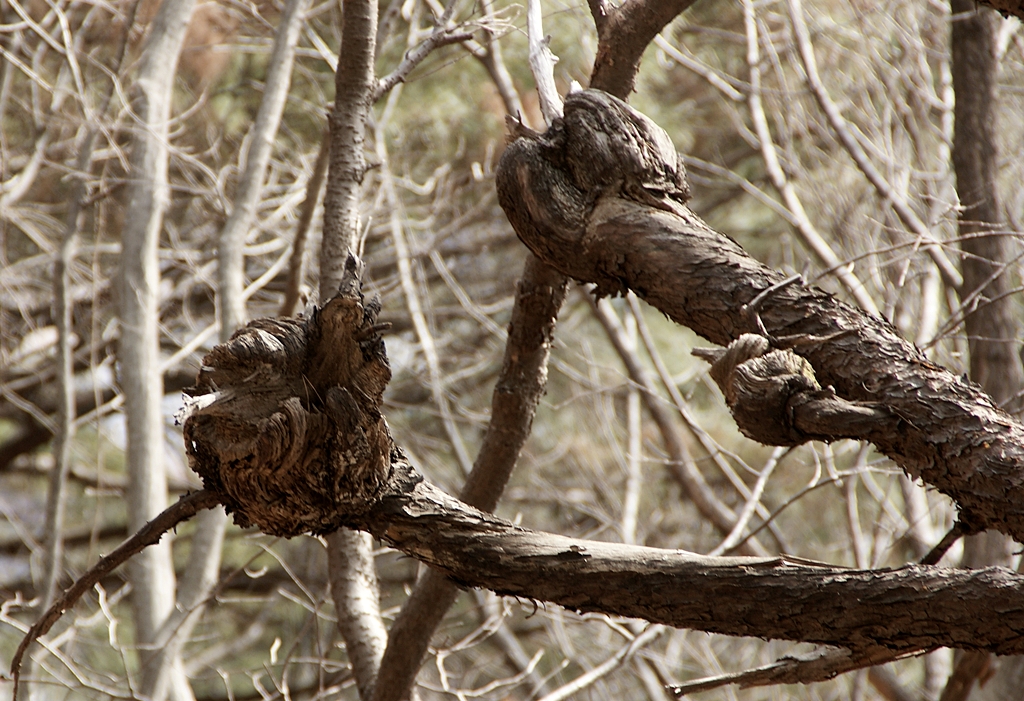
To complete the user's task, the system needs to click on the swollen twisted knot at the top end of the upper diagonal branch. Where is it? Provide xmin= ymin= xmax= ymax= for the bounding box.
xmin=496 ymin=90 xmax=690 ymax=293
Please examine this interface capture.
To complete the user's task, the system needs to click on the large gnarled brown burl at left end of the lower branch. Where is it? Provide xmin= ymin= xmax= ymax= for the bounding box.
xmin=183 ymin=257 xmax=394 ymax=536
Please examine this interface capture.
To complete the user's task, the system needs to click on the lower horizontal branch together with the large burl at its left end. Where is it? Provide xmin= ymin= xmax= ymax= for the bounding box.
xmin=130 ymin=249 xmax=1024 ymax=660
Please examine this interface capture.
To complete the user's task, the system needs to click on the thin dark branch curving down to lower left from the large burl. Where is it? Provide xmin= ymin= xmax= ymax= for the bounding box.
xmin=10 ymin=489 xmax=220 ymax=701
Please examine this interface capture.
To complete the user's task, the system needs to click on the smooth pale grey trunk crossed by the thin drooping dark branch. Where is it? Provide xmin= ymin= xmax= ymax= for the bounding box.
xmin=118 ymin=0 xmax=196 ymax=700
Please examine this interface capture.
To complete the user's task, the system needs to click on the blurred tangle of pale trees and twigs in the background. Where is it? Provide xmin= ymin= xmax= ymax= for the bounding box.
xmin=0 ymin=0 xmax=1024 ymax=699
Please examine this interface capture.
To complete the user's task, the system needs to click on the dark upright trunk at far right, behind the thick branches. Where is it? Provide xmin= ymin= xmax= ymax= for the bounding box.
xmin=942 ymin=0 xmax=1024 ymax=701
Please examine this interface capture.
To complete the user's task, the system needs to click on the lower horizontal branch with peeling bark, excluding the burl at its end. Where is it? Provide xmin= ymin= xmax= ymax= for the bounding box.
xmin=358 ymin=459 xmax=1024 ymax=654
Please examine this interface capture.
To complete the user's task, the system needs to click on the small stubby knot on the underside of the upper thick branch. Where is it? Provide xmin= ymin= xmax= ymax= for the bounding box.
xmin=693 ymin=334 xmax=893 ymax=445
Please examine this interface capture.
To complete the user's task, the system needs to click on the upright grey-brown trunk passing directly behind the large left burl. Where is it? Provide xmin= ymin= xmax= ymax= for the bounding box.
xmin=319 ymin=0 xmax=387 ymax=700
